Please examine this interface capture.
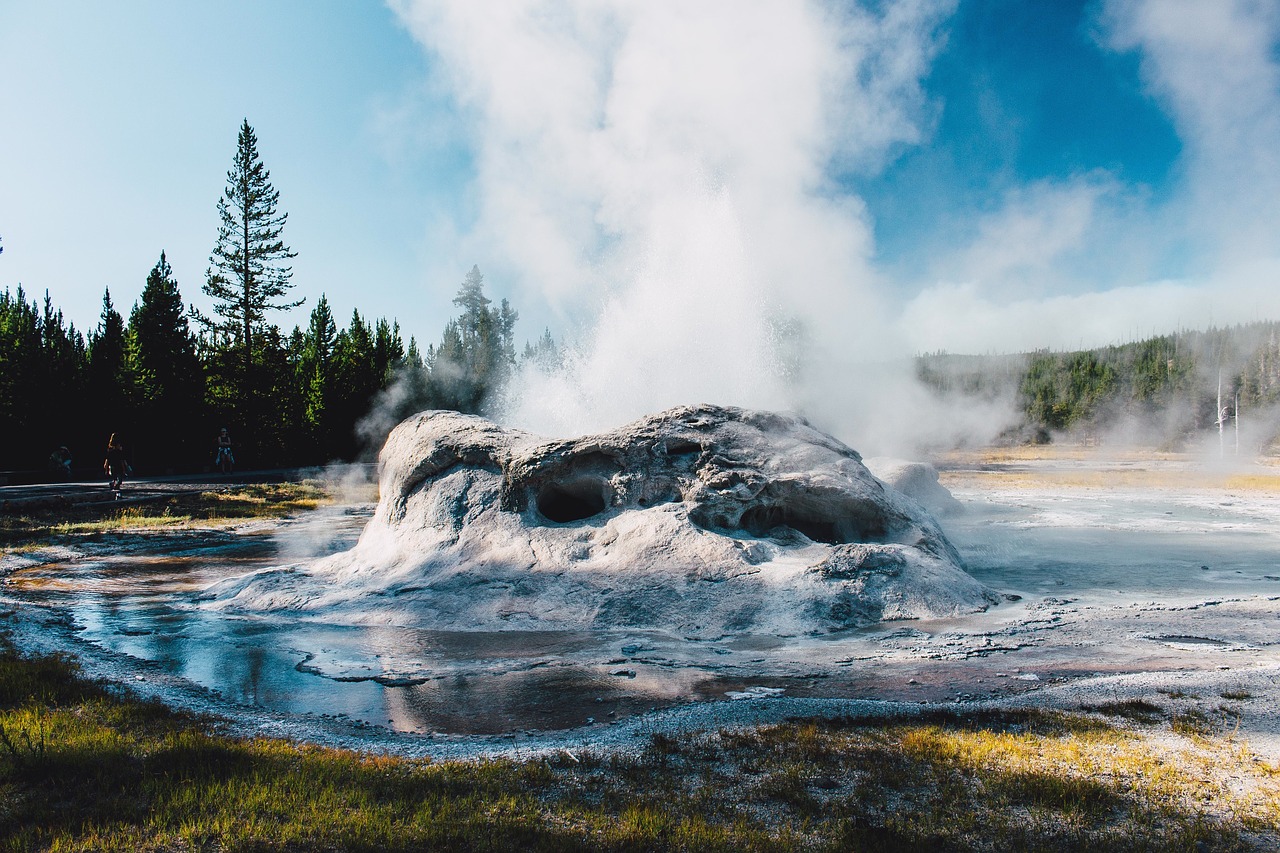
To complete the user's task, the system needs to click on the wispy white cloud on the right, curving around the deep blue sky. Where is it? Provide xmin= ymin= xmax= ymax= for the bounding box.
xmin=899 ymin=0 xmax=1280 ymax=352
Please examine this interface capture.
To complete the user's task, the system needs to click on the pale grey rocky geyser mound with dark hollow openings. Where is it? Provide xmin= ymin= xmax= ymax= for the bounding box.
xmin=207 ymin=406 xmax=997 ymax=638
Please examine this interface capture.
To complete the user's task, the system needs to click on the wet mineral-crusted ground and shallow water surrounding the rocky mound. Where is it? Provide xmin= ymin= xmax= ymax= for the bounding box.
xmin=4 ymin=455 xmax=1280 ymax=744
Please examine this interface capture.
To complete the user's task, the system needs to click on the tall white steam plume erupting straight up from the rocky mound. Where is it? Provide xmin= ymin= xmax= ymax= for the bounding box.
xmin=398 ymin=0 xmax=977 ymax=450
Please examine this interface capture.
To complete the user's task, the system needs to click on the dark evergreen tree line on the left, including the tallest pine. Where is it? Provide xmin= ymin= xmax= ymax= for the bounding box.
xmin=0 ymin=120 xmax=559 ymax=474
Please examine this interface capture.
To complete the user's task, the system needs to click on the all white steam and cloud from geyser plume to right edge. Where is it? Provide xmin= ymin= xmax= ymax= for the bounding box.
xmin=392 ymin=0 xmax=1280 ymax=452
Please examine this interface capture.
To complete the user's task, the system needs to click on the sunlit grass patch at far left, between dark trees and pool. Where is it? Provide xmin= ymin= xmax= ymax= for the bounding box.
xmin=0 ymin=480 xmax=332 ymax=540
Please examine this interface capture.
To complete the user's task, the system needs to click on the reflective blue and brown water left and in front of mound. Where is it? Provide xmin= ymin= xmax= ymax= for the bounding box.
xmin=10 ymin=519 xmax=768 ymax=734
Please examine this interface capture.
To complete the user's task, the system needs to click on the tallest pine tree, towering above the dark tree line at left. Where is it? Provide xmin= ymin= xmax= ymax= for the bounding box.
xmin=200 ymin=119 xmax=302 ymax=397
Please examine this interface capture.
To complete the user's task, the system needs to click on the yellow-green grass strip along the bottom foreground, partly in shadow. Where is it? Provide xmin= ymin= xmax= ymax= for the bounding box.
xmin=0 ymin=617 xmax=1280 ymax=852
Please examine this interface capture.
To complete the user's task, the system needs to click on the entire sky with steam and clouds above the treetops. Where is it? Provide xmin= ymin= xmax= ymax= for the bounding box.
xmin=0 ymin=0 xmax=1280 ymax=371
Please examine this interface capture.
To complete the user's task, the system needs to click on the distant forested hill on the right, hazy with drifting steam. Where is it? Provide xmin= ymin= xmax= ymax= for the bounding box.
xmin=915 ymin=323 xmax=1280 ymax=446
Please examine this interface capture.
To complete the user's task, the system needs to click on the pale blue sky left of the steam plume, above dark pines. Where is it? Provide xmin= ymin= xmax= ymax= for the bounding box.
xmin=0 ymin=0 xmax=480 ymax=337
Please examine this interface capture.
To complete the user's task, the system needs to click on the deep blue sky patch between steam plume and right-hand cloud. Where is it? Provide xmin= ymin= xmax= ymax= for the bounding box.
xmin=854 ymin=0 xmax=1180 ymax=279
